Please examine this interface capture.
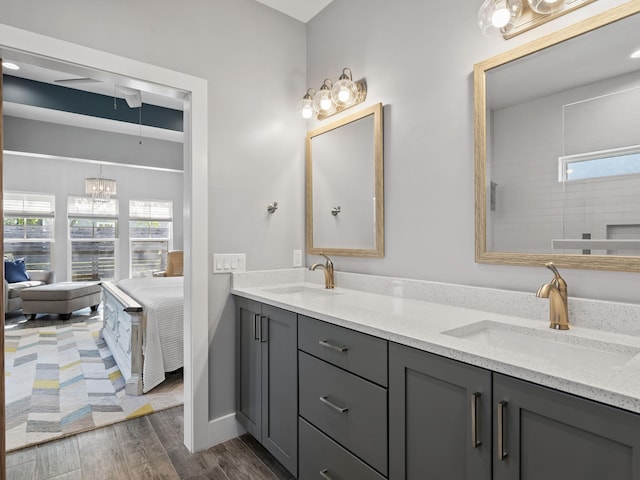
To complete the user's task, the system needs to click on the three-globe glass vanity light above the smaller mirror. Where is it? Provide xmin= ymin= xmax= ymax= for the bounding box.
xmin=296 ymin=67 xmax=367 ymax=120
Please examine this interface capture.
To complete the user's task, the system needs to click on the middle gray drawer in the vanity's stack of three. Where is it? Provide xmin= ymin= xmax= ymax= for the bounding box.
xmin=298 ymin=352 xmax=387 ymax=475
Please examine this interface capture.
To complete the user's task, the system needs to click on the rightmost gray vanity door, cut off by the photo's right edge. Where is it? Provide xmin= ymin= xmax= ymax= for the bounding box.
xmin=493 ymin=374 xmax=640 ymax=480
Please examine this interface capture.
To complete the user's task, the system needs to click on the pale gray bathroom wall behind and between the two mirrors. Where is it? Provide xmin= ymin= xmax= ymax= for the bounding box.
xmin=307 ymin=0 xmax=639 ymax=302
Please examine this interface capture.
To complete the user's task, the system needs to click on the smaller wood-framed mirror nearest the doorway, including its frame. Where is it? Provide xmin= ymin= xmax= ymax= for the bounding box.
xmin=307 ymin=104 xmax=384 ymax=257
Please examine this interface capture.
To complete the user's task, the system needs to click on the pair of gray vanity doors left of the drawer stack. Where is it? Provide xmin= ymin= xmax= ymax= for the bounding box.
xmin=236 ymin=297 xmax=298 ymax=475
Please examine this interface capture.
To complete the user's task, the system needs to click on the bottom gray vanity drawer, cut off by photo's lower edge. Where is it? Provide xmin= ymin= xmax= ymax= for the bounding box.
xmin=298 ymin=418 xmax=384 ymax=480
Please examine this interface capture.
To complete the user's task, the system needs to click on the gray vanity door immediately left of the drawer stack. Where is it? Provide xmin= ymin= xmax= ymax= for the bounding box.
xmin=260 ymin=305 xmax=298 ymax=475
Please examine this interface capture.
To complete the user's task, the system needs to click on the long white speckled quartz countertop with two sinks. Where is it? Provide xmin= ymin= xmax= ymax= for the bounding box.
xmin=231 ymin=283 xmax=640 ymax=413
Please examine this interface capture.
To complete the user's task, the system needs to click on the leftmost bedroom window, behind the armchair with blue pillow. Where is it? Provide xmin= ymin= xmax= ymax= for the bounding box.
xmin=4 ymin=192 xmax=55 ymax=270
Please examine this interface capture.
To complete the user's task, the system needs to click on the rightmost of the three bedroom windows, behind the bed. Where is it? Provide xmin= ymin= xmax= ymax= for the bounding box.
xmin=129 ymin=200 xmax=173 ymax=278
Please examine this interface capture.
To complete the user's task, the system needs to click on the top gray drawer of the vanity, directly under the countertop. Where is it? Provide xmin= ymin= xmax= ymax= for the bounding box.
xmin=298 ymin=315 xmax=387 ymax=387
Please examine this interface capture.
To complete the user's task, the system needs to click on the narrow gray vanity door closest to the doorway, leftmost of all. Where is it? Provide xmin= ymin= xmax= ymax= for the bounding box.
xmin=236 ymin=297 xmax=262 ymax=440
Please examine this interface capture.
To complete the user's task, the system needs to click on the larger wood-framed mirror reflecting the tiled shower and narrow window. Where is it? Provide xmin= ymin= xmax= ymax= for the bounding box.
xmin=474 ymin=2 xmax=640 ymax=271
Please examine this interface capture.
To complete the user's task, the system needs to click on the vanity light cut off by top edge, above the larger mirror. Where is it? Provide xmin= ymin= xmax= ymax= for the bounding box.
xmin=478 ymin=0 xmax=595 ymax=40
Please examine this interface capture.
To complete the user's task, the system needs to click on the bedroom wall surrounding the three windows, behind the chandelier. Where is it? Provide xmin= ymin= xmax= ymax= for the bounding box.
xmin=3 ymin=154 xmax=184 ymax=281
